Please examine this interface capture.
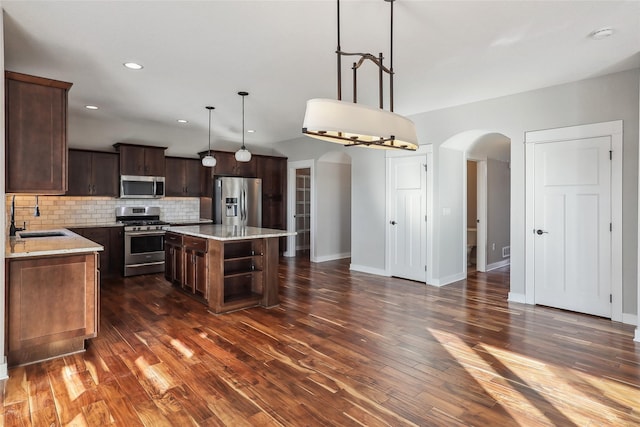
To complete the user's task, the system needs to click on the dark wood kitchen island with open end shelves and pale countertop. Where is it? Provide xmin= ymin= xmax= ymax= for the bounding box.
xmin=165 ymin=224 xmax=295 ymax=314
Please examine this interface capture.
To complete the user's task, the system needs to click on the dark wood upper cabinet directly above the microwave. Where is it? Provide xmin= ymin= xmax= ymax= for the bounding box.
xmin=113 ymin=142 xmax=167 ymax=176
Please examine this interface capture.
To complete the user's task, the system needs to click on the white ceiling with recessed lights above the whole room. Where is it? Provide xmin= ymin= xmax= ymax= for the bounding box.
xmin=1 ymin=0 xmax=640 ymax=157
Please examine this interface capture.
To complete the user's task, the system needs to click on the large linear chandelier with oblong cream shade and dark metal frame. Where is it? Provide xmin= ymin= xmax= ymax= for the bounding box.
xmin=302 ymin=0 xmax=418 ymax=151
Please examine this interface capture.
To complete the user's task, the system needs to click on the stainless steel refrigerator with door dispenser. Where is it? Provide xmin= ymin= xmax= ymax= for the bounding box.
xmin=212 ymin=177 xmax=262 ymax=227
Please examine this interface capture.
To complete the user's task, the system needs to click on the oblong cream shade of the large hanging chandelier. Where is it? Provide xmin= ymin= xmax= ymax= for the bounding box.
xmin=302 ymin=98 xmax=418 ymax=150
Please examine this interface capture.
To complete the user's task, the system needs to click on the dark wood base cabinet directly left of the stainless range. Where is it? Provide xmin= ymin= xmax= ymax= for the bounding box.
xmin=70 ymin=227 xmax=124 ymax=277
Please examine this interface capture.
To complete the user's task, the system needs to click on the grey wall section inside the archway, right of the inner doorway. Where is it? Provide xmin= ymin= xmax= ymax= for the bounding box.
xmin=487 ymin=159 xmax=511 ymax=268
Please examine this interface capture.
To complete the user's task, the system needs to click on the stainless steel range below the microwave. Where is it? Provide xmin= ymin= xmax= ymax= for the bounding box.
xmin=116 ymin=206 xmax=169 ymax=277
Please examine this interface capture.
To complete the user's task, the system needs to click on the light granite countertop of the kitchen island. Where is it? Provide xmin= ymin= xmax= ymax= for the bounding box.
xmin=167 ymin=224 xmax=296 ymax=240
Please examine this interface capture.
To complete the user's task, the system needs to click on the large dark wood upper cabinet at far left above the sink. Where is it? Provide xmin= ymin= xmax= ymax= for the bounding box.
xmin=5 ymin=71 xmax=72 ymax=195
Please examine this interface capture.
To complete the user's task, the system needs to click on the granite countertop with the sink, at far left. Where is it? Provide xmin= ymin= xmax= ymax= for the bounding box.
xmin=5 ymin=228 xmax=104 ymax=258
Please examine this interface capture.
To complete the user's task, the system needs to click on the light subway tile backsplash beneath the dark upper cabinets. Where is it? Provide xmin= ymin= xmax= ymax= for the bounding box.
xmin=6 ymin=194 xmax=200 ymax=230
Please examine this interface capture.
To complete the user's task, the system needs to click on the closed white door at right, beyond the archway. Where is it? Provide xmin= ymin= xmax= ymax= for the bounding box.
xmin=532 ymin=137 xmax=611 ymax=318
